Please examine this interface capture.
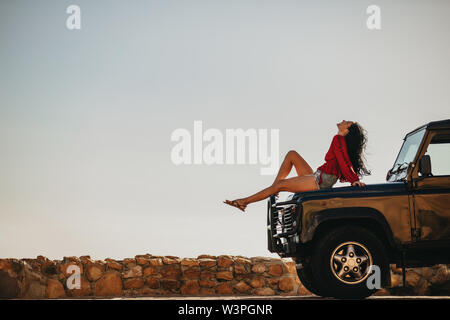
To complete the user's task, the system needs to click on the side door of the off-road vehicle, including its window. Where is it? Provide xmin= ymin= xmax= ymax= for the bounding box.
xmin=412 ymin=129 xmax=450 ymax=243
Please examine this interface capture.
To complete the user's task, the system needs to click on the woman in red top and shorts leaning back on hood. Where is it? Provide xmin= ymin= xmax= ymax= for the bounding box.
xmin=224 ymin=120 xmax=370 ymax=211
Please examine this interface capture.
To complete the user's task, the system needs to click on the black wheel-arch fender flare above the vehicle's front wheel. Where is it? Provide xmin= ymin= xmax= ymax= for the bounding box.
xmin=301 ymin=207 xmax=398 ymax=248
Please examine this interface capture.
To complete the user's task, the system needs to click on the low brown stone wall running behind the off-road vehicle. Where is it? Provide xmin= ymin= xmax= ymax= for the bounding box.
xmin=0 ymin=254 xmax=450 ymax=299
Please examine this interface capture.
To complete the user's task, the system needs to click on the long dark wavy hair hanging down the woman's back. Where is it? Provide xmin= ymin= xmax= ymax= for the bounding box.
xmin=345 ymin=122 xmax=371 ymax=177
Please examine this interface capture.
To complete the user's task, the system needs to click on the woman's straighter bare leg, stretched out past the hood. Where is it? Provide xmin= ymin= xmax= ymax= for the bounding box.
xmin=229 ymin=175 xmax=318 ymax=210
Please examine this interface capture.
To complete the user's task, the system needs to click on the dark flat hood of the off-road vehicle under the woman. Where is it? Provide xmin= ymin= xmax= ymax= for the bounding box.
xmin=290 ymin=181 xmax=408 ymax=201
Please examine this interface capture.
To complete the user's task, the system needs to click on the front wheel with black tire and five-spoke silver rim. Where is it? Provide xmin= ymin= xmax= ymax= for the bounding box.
xmin=311 ymin=226 xmax=390 ymax=299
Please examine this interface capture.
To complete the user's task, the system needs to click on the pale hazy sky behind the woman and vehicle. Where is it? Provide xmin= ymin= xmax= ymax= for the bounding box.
xmin=0 ymin=0 xmax=450 ymax=259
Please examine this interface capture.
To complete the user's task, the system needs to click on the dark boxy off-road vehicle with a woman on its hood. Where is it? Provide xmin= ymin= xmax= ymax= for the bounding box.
xmin=267 ymin=119 xmax=450 ymax=299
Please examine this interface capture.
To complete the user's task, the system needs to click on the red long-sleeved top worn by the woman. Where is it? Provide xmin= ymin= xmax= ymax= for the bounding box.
xmin=317 ymin=134 xmax=359 ymax=184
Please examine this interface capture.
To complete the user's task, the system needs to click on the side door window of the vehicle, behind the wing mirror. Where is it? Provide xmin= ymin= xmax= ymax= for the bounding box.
xmin=425 ymin=135 xmax=450 ymax=176
